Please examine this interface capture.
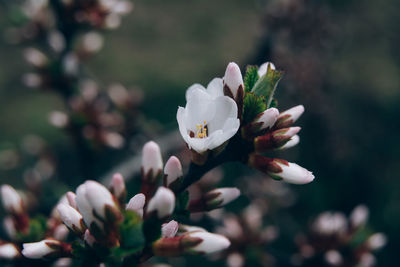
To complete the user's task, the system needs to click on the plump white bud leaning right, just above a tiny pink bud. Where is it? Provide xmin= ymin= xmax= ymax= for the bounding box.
xmin=147 ymin=187 xmax=175 ymax=219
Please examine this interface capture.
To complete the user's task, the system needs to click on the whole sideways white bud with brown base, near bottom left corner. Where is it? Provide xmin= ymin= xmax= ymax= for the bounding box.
xmin=22 ymin=239 xmax=72 ymax=259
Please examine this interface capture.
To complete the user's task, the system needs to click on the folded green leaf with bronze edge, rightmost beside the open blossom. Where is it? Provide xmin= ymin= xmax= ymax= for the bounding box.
xmin=251 ymin=67 xmax=283 ymax=107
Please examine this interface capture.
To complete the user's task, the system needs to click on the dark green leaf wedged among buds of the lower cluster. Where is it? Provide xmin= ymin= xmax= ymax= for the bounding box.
xmin=119 ymin=211 xmax=145 ymax=253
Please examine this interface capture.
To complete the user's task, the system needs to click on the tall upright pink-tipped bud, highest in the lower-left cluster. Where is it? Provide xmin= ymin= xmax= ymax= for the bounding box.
xmin=142 ymin=141 xmax=163 ymax=178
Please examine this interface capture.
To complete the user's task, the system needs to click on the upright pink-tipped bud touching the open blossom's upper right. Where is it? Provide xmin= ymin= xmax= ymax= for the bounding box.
xmin=223 ymin=62 xmax=244 ymax=100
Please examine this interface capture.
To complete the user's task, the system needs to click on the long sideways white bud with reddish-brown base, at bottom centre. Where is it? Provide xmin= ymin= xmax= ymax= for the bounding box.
xmin=153 ymin=231 xmax=230 ymax=257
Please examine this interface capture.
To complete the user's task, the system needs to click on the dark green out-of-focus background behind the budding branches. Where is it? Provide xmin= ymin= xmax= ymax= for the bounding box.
xmin=0 ymin=0 xmax=400 ymax=266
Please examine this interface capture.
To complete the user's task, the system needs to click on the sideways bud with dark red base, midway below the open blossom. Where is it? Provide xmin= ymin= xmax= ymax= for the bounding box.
xmin=188 ymin=187 xmax=240 ymax=212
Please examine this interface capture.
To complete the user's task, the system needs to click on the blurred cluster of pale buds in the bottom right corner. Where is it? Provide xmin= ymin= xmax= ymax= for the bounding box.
xmin=292 ymin=205 xmax=387 ymax=267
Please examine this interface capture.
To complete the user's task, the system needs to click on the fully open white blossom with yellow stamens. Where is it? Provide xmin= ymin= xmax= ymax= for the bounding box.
xmin=176 ymin=78 xmax=240 ymax=153
